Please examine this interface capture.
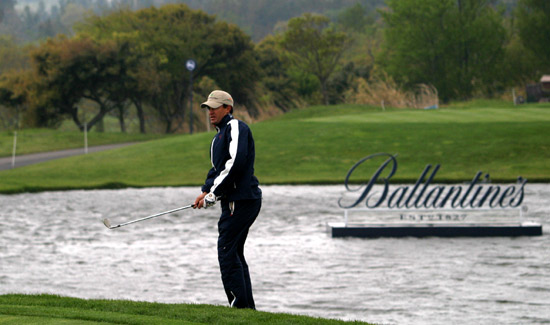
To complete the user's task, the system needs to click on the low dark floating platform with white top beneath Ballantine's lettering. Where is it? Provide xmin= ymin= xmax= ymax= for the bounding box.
xmin=327 ymin=222 xmax=542 ymax=238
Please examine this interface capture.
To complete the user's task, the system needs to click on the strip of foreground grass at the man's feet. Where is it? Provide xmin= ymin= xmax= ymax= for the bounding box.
xmin=0 ymin=294 xmax=366 ymax=325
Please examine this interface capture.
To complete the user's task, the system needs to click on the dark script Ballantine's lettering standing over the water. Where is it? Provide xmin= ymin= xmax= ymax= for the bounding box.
xmin=338 ymin=153 xmax=527 ymax=209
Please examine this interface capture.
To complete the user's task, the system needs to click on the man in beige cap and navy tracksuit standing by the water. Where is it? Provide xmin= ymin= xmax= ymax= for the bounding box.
xmin=194 ymin=90 xmax=262 ymax=309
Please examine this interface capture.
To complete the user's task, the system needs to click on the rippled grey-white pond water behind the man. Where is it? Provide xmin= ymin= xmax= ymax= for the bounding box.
xmin=0 ymin=185 xmax=550 ymax=324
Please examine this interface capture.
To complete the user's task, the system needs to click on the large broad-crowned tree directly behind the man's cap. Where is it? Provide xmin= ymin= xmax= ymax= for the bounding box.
xmin=77 ymin=5 xmax=259 ymax=133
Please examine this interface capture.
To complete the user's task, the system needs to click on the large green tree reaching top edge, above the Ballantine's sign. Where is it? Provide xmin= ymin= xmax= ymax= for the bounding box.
xmin=380 ymin=0 xmax=507 ymax=101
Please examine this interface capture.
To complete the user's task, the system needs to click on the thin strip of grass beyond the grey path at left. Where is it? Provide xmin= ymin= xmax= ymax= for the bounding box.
xmin=0 ymin=129 xmax=166 ymax=157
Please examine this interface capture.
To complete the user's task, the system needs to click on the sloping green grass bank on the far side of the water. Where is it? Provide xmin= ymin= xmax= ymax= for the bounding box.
xmin=0 ymin=101 xmax=550 ymax=193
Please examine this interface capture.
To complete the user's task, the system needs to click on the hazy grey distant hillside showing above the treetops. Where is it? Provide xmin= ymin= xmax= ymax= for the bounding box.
xmin=0 ymin=0 xmax=388 ymax=42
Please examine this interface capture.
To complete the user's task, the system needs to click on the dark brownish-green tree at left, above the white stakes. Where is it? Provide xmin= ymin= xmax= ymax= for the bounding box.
xmin=31 ymin=37 xmax=132 ymax=130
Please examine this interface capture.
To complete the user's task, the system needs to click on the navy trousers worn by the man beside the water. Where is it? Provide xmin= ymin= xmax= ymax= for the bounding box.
xmin=218 ymin=199 xmax=262 ymax=309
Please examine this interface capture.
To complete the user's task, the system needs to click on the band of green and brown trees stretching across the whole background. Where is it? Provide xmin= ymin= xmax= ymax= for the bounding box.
xmin=0 ymin=0 xmax=550 ymax=133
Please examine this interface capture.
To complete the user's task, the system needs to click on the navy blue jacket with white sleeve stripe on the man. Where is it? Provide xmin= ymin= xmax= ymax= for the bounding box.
xmin=202 ymin=114 xmax=262 ymax=202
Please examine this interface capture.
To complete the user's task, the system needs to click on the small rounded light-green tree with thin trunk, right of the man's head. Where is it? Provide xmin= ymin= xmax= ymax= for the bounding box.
xmin=281 ymin=14 xmax=348 ymax=105
